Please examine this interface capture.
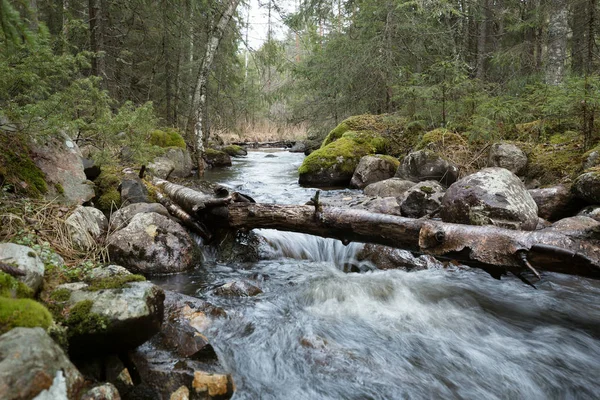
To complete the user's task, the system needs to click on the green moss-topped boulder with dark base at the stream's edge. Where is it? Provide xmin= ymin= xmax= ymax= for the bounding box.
xmin=298 ymin=131 xmax=386 ymax=187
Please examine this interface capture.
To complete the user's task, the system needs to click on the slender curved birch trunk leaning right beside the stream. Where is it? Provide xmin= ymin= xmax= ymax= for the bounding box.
xmin=192 ymin=0 xmax=240 ymax=176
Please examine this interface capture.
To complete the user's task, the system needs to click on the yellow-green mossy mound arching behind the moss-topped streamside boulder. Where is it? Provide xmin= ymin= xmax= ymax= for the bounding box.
xmin=321 ymin=114 xmax=423 ymax=156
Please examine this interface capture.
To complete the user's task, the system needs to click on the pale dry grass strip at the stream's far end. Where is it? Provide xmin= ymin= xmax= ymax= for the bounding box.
xmin=216 ymin=121 xmax=307 ymax=143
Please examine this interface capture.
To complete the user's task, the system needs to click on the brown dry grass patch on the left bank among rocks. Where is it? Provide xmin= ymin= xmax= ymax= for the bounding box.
xmin=0 ymin=194 xmax=109 ymax=266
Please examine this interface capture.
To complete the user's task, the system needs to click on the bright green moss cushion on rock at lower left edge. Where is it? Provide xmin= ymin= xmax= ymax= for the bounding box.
xmin=0 ymin=297 xmax=52 ymax=334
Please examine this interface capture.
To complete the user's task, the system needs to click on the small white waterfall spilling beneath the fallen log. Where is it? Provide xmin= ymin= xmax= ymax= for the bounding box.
xmin=256 ymin=229 xmax=373 ymax=269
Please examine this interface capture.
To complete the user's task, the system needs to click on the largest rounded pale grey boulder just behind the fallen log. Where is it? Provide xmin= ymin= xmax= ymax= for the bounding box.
xmin=441 ymin=168 xmax=538 ymax=230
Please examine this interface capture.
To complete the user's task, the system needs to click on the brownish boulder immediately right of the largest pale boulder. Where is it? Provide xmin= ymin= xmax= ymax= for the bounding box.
xmin=529 ymin=185 xmax=583 ymax=221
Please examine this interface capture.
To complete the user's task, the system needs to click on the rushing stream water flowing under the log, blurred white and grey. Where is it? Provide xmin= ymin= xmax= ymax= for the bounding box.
xmin=152 ymin=151 xmax=600 ymax=400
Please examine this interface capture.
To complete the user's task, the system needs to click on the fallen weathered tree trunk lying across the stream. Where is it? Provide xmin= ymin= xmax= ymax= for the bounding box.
xmin=151 ymin=184 xmax=600 ymax=279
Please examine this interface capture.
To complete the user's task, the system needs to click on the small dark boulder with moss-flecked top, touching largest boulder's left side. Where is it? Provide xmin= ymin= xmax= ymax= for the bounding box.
xmin=398 ymin=181 xmax=444 ymax=218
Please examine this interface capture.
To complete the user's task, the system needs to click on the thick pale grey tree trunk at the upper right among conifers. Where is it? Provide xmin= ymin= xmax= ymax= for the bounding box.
xmin=546 ymin=0 xmax=569 ymax=85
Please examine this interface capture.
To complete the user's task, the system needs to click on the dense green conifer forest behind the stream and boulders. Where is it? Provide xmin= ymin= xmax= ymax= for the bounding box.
xmin=0 ymin=0 xmax=600 ymax=177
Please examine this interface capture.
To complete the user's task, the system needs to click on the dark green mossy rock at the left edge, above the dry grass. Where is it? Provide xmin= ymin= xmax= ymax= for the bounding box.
xmin=0 ymin=133 xmax=48 ymax=197
